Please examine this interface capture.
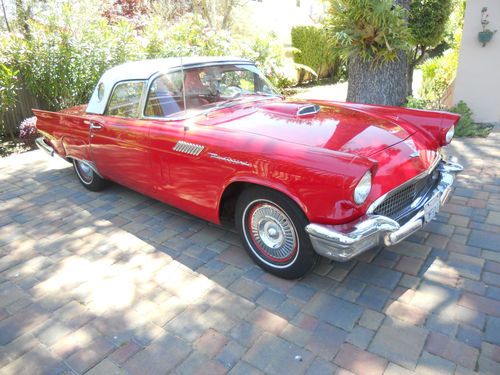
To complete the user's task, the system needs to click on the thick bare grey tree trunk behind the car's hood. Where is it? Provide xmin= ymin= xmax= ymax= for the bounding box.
xmin=347 ymin=51 xmax=408 ymax=106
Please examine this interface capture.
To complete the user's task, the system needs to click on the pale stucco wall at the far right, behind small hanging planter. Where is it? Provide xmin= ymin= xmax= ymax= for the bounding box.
xmin=453 ymin=0 xmax=500 ymax=122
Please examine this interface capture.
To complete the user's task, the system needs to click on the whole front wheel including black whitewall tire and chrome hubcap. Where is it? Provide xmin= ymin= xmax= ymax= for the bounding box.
xmin=235 ymin=188 xmax=318 ymax=279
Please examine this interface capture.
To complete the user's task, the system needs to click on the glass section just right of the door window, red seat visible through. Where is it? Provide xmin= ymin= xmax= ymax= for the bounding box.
xmin=144 ymin=72 xmax=184 ymax=117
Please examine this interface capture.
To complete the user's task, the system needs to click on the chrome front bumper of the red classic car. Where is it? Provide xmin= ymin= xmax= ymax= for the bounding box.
xmin=306 ymin=161 xmax=463 ymax=262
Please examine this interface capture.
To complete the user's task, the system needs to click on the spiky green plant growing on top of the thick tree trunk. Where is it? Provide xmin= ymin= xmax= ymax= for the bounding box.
xmin=325 ymin=0 xmax=410 ymax=63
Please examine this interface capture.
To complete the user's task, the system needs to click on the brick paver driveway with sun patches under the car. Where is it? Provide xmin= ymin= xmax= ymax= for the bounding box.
xmin=0 ymin=127 xmax=500 ymax=375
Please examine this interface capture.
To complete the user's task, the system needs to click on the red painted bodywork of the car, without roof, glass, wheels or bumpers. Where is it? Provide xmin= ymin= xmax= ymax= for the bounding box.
xmin=34 ymin=99 xmax=459 ymax=224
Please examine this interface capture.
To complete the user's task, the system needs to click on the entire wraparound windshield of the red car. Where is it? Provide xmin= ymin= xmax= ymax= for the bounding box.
xmin=144 ymin=64 xmax=278 ymax=118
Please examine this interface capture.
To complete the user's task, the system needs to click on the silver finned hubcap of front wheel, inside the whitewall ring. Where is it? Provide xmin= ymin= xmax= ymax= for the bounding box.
xmin=249 ymin=203 xmax=297 ymax=262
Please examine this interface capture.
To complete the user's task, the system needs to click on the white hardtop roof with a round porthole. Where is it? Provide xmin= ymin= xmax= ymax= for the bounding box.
xmin=86 ymin=56 xmax=253 ymax=115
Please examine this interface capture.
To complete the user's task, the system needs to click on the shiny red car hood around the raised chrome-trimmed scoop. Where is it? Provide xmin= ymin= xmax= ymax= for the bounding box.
xmin=198 ymin=101 xmax=412 ymax=157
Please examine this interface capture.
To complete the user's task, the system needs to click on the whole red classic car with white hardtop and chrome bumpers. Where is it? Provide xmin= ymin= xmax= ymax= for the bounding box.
xmin=34 ymin=57 xmax=462 ymax=278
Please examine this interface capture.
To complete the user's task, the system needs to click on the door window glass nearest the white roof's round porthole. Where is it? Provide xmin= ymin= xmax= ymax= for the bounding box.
xmin=106 ymin=81 xmax=144 ymax=118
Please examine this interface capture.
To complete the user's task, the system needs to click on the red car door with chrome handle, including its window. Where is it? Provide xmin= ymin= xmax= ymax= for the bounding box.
xmin=90 ymin=80 xmax=153 ymax=193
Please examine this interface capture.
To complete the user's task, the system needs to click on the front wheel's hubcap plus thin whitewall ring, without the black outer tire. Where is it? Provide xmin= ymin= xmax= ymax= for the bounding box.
xmin=244 ymin=201 xmax=299 ymax=268
